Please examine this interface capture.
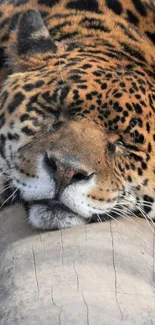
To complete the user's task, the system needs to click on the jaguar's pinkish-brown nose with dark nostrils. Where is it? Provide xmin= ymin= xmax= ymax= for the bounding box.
xmin=44 ymin=154 xmax=94 ymax=187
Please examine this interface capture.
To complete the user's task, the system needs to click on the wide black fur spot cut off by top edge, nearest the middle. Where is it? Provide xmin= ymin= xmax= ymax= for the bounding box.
xmin=66 ymin=0 xmax=99 ymax=12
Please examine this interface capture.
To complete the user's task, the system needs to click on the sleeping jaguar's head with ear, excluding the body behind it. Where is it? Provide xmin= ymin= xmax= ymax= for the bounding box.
xmin=0 ymin=10 xmax=155 ymax=229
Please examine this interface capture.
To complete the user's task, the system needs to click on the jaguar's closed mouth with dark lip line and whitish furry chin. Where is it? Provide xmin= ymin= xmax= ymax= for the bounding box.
xmin=1 ymin=177 xmax=123 ymax=230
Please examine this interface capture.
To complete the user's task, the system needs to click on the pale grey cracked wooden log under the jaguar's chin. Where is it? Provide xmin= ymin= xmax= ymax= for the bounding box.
xmin=0 ymin=206 xmax=155 ymax=325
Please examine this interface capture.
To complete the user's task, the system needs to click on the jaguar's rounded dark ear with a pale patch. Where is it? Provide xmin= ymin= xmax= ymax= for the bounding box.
xmin=8 ymin=10 xmax=57 ymax=71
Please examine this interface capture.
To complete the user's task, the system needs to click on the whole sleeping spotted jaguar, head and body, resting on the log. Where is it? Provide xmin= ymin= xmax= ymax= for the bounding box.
xmin=0 ymin=0 xmax=155 ymax=230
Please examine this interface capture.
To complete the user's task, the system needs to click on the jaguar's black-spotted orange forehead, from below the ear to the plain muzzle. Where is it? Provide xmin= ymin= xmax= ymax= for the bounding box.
xmin=1 ymin=59 xmax=153 ymax=151
